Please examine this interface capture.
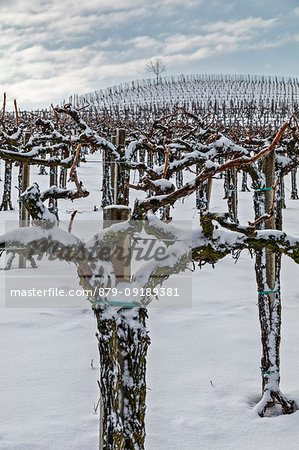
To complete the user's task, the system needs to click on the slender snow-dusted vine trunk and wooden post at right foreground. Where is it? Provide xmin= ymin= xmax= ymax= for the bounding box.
xmin=255 ymin=152 xmax=295 ymax=417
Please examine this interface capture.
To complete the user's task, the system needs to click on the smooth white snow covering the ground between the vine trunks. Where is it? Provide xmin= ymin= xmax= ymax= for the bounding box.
xmin=0 ymin=154 xmax=299 ymax=450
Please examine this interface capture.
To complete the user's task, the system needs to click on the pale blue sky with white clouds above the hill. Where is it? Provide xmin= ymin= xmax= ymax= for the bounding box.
xmin=0 ymin=0 xmax=299 ymax=109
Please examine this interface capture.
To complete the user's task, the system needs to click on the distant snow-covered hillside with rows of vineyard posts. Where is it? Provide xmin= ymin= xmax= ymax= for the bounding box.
xmin=69 ymin=74 xmax=299 ymax=129
